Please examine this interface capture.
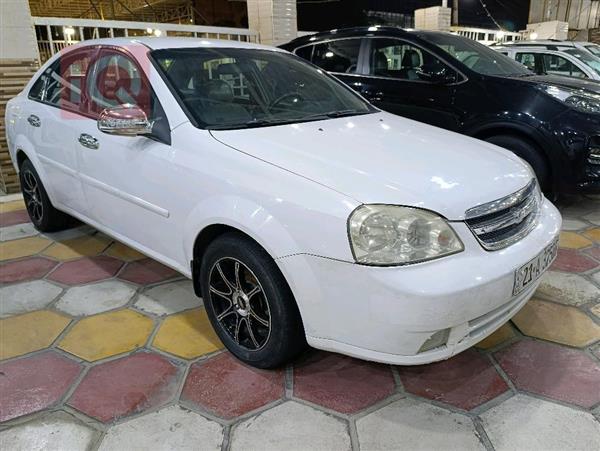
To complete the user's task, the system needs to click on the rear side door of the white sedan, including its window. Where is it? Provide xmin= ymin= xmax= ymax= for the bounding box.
xmin=26 ymin=47 xmax=97 ymax=215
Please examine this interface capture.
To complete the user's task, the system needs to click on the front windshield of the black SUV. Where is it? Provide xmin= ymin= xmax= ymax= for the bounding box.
xmin=422 ymin=33 xmax=532 ymax=76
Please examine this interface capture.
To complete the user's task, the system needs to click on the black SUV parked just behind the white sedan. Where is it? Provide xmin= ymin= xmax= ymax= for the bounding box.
xmin=281 ymin=27 xmax=600 ymax=194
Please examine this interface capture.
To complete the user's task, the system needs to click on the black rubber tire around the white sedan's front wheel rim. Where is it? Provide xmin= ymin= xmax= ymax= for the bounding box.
xmin=200 ymin=233 xmax=306 ymax=368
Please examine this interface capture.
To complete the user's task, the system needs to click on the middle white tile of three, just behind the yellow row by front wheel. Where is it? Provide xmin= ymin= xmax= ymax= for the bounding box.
xmin=55 ymin=280 xmax=136 ymax=316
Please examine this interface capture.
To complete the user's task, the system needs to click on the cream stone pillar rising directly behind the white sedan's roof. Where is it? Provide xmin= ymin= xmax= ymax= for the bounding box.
xmin=248 ymin=0 xmax=298 ymax=45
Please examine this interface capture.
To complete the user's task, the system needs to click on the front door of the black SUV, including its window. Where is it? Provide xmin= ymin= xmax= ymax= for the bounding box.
xmin=360 ymin=37 xmax=466 ymax=130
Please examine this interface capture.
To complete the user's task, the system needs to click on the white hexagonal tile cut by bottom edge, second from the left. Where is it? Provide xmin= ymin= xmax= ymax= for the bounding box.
xmin=99 ymin=406 xmax=223 ymax=451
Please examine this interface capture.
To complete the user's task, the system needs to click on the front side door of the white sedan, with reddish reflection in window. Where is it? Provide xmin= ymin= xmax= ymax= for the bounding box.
xmin=79 ymin=48 xmax=181 ymax=260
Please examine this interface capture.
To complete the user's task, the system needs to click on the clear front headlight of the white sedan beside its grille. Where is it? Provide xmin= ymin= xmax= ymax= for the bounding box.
xmin=348 ymin=205 xmax=464 ymax=266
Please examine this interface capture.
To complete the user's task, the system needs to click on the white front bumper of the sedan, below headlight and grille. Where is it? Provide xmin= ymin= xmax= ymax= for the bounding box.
xmin=277 ymin=200 xmax=561 ymax=365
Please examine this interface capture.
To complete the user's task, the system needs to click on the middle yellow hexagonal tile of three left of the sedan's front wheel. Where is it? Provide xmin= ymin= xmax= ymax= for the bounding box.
xmin=58 ymin=310 xmax=154 ymax=362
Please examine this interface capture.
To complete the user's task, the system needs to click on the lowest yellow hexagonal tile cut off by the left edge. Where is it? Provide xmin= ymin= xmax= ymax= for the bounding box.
xmin=0 ymin=310 xmax=71 ymax=360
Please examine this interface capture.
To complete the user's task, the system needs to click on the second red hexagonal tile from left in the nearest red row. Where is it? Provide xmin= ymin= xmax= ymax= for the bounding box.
xmin=68 ymin=352 xmax=180 ymax=422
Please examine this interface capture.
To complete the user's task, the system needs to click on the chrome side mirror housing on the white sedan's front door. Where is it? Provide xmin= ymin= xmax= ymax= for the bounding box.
xmin=98 ymin=105 xmax=153 ymax=136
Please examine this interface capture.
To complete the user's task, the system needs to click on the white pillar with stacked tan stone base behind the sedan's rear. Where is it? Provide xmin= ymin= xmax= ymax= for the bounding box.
xmin=0 ymin=0 xmax=39 ymax=192
